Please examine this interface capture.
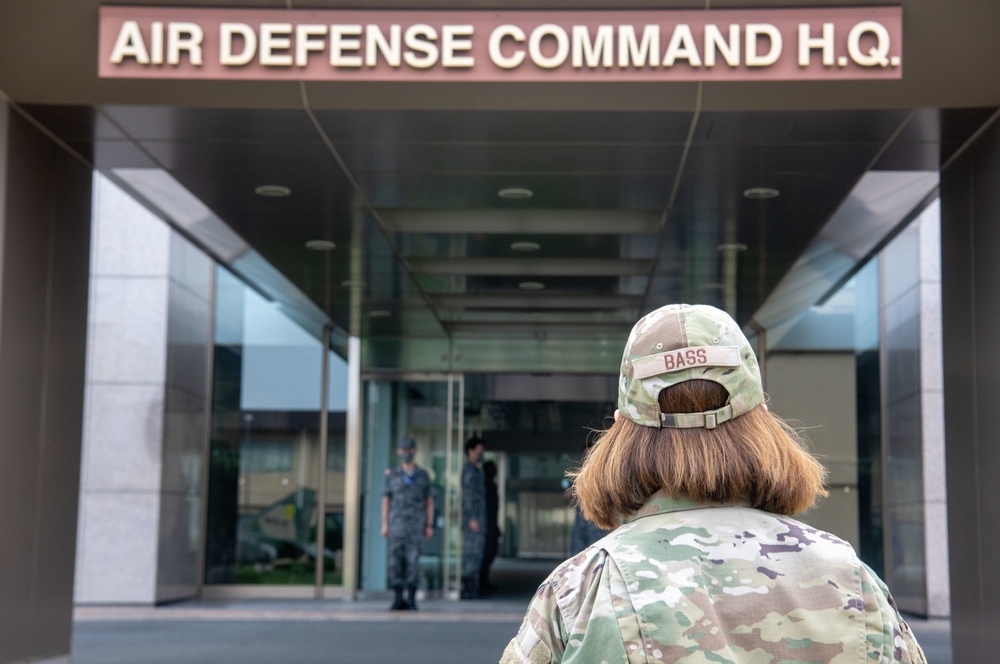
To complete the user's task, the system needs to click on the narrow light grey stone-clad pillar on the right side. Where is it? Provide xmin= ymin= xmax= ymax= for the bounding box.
xmin=879 ymin=204 xmax=950 ymax=617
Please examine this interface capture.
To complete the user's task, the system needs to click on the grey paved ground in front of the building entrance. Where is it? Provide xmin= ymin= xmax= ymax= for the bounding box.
xmin=73 ymin=562 xmax=952 ymax=664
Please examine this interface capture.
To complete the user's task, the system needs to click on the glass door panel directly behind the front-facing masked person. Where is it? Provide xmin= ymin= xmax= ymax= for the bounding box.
xmin=359 ymin=374 xmax=464 ymax=597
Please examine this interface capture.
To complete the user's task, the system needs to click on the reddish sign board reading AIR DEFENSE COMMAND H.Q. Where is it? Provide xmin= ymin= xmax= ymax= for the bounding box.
xmin=98 ymin=6 xmax=903 ymax=82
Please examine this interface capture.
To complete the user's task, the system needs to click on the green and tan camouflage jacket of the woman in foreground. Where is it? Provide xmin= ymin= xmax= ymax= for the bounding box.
xmin=501 ymin=493 xmax=926 ymax=664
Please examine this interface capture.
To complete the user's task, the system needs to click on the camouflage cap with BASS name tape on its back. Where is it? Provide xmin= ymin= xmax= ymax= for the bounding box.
xmin=618 ymin=304 xmax=764 ymax=429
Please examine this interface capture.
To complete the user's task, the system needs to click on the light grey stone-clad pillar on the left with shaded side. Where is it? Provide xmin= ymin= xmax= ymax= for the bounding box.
xmin=76 ymin=177 xmax=213 ymax=604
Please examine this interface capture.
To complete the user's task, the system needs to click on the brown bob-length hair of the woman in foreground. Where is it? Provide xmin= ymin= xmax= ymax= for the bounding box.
xmin=571 ymin=380 xmax=827 ymax=529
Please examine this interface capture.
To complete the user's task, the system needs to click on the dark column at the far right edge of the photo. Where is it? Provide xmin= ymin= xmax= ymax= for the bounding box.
xmin=941 ymin=114 xmax=1000 ymax=662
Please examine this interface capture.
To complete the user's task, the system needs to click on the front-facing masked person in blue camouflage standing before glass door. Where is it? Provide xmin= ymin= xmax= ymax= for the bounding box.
xmin=382 ymin=438 xmax=434 ymax=611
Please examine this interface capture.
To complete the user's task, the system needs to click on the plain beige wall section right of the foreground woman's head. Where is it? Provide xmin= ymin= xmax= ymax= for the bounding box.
xmin=766 ymin=351 xmax=859 ymax=549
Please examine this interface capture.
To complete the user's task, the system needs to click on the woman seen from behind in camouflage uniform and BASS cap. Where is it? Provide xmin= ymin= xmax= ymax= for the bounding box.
xmin=501 ymin=305 xmax=926 ymax=664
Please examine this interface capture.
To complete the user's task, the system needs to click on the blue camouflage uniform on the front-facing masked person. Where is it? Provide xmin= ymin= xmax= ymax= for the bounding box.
xmin=382 ymin=466 xmax=431 ymax=588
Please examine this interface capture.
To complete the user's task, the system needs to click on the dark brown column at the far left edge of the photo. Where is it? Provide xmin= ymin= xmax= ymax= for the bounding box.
xmin=0 ymin=102 xmax=91 ymax=664
